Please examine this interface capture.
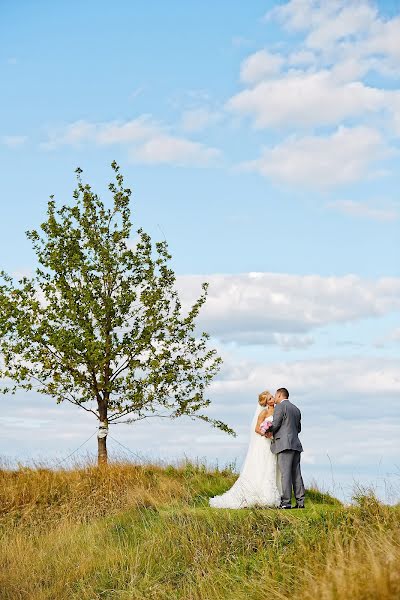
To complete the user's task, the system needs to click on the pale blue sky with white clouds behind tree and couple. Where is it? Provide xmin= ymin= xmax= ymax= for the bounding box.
xmin=0 ymin=0 xmax=400 ymax=502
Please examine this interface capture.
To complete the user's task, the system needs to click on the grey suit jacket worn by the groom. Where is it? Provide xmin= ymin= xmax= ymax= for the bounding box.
xmin=269 ymin=400 xmax=303 ymax=454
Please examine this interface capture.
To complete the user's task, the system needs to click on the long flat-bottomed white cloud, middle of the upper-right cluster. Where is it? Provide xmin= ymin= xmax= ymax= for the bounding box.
xmin=227 ymin=71 xmax=385 ymax=128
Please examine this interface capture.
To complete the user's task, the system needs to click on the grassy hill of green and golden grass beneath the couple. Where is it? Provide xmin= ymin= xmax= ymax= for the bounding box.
xmin=0 ymin=463 xmax=400 ymax=600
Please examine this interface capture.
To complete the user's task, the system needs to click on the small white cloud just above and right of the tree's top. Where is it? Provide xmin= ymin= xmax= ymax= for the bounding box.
xmin=131 ymin=135 xmax=222 ymax=167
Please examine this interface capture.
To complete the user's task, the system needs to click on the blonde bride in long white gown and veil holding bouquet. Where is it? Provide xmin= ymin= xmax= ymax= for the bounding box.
xmin=210 ymin=391 xmax=281 ymax=508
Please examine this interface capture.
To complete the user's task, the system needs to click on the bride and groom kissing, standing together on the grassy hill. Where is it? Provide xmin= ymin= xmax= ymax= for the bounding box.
xmin=210 ymin=388 xmax=305 ymax=509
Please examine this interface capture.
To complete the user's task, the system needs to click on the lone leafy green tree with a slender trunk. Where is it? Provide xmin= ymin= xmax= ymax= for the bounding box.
xmin=0 ymin=162 xmax=234 ymax=464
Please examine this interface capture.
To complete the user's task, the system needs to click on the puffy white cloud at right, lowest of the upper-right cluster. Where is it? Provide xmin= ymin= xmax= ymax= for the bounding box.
xmin=243 ymin=126 xmax=389 ymax=188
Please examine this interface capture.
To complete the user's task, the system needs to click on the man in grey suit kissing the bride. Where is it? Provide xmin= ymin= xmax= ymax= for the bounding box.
xmin=269 ymin=388 xmax=305 ymax=508
